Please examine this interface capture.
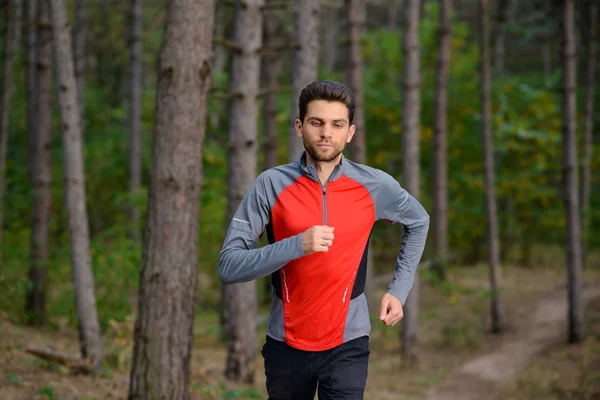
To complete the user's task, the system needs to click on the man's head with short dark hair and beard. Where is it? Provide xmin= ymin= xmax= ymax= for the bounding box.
xmin=296 ymin=81 xmax=355 ymax=162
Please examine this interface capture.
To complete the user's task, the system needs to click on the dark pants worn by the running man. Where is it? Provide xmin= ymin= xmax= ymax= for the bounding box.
xmin=262 ymin=336 xmax=370 ymax=400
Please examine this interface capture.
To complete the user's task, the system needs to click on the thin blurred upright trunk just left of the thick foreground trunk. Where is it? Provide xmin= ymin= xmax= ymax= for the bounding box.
xmin=127 ymin=0 xmax=142 ymax=243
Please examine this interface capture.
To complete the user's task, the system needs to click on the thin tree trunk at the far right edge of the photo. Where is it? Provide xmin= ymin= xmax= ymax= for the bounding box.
xmin=581 ymin=2 xmax=598 ymax=265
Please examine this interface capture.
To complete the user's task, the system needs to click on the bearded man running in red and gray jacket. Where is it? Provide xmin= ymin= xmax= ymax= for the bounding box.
xmin=219 ymin=81 xmax=429 ymax=400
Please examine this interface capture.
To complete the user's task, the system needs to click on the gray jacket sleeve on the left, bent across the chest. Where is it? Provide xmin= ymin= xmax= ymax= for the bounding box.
xmin=218 ymin=173 xmax=304 ymax=284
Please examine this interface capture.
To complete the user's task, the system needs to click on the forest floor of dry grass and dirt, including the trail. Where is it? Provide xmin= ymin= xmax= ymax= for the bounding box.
xmin=0 ymin=266 xmax=600 ymax=400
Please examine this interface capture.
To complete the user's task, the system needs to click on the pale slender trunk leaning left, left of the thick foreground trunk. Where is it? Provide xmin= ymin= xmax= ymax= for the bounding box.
xmin=50 ymin=0 xmax=102 ymax=369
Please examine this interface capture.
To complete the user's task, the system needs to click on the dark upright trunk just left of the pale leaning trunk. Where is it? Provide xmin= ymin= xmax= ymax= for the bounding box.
xmin=27 ymin=0 xmax=53 ymax=325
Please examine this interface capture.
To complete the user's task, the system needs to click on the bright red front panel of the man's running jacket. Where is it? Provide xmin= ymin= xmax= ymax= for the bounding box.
xmin=271 ymin=176 xmax=375 ymax=350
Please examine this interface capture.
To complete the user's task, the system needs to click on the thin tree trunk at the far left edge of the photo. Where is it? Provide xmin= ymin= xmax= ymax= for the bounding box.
xmin=0 ymin=0 xmax=15 ymax=252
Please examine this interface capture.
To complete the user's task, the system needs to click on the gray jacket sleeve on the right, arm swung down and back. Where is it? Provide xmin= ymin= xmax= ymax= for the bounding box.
xmin=375 ymin=173 xmax=429 ymax=305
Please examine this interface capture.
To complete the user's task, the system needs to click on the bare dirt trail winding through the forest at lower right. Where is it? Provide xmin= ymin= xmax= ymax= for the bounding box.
xmin=427 ymin=287 xmax=600 ymax=400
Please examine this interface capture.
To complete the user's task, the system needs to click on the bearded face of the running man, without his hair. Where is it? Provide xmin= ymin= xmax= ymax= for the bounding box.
xmin=296 ymin=100 xmax=355 ymax=162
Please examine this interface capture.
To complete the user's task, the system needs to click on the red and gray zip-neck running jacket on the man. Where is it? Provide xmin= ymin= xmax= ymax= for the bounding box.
xmin=219 ymin=154 xmax=429 ymax=351
